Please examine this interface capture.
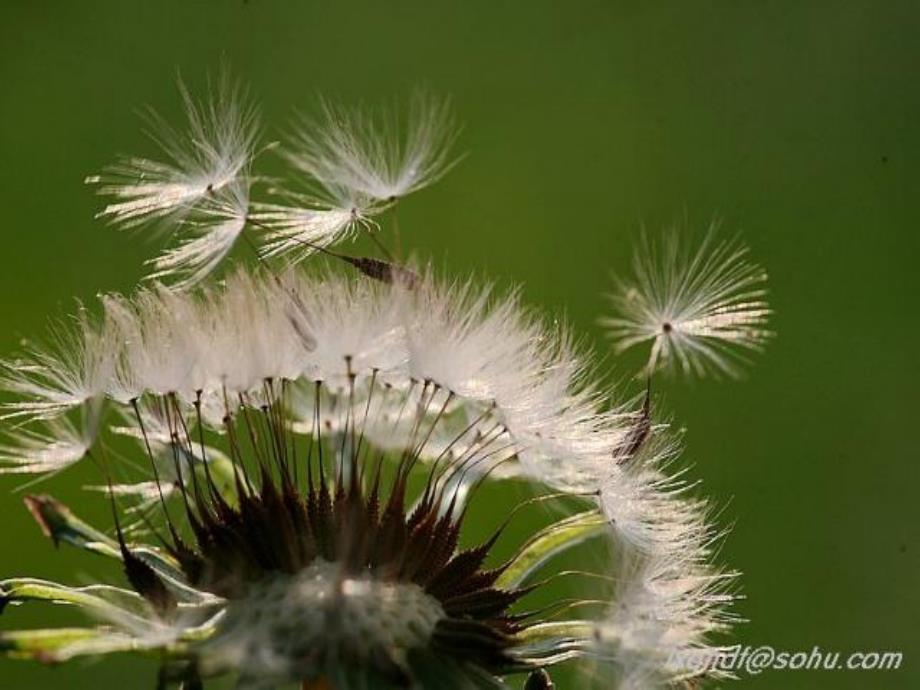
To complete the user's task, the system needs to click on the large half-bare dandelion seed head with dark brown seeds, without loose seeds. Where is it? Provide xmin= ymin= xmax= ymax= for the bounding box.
xmin=2 ymin=269 xmax=748 ymax=684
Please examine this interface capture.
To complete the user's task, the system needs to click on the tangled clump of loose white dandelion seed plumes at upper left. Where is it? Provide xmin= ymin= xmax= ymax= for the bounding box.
xmin=86 ymin=82 xmax=456 ymax=280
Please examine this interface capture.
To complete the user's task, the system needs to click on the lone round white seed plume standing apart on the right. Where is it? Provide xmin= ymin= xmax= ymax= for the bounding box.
xmin=602 ymin=228 xmax=771 ymax=376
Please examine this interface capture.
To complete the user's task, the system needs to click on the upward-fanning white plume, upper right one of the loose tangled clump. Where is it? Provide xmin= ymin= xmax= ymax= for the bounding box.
xmin=284 ymin=92 xmax=456 ymax=202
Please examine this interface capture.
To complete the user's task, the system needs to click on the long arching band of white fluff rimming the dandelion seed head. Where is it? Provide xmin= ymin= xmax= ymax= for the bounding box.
xmin=0 ymin=262 xmax=744 ymax=687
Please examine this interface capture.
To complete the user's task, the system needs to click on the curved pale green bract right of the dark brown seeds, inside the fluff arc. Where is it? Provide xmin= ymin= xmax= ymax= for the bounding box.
xmin=495 ymin=509 xmax=607 ymax=589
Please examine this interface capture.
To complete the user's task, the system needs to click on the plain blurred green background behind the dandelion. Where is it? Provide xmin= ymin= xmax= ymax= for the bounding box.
xmin=0 ymin=0 xmax=920 ymax=690
